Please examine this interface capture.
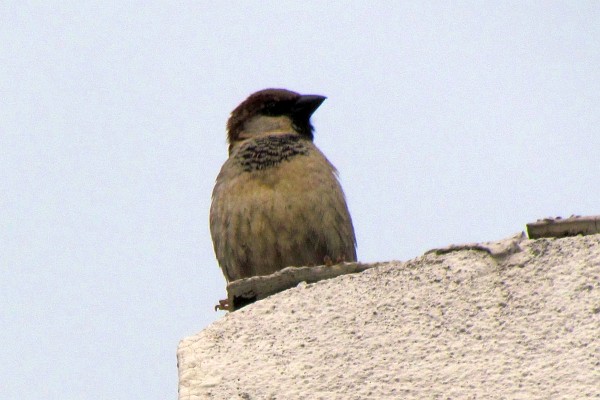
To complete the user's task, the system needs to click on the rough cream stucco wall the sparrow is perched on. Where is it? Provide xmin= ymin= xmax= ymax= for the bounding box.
xmin=177 ymin=235 xmax=600 ymax=400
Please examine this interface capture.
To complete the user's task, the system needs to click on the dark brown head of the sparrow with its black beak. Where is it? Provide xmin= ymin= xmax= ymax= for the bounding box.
xmin=227 ymin=89 xmax=326 ymax=152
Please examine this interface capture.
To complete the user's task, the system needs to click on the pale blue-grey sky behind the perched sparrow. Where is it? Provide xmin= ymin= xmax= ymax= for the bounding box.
xmin=0 ymin=1 xmax=600 ymax=400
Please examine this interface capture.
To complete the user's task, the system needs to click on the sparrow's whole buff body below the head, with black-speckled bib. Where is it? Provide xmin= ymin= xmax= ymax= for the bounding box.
xmin=210 ymin=133 xmax=356 ymax=281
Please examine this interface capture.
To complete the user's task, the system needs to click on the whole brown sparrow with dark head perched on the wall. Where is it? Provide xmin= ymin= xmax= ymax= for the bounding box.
xmin=210 ymin=89 xmax=357 ymax=290
